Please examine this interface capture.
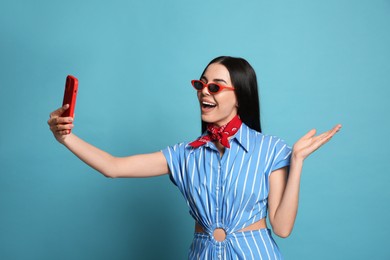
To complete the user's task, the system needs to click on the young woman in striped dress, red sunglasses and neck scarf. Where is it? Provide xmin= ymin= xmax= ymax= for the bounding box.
xmin=48 ymin=56 xmax=341 ymax=259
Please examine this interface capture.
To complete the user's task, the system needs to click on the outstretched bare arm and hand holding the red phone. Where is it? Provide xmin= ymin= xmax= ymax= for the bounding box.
xmin=48 ymin=105 xmax=168 ymax=178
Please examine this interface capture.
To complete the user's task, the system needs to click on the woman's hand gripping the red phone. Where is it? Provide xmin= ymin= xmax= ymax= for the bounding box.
xmin=47 ymin=104 xmax=74 ymax=143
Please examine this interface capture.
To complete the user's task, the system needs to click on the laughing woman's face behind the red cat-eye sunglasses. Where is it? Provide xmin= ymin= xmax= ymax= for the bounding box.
xmin=198 ymin=63 xmax=237 ymax=126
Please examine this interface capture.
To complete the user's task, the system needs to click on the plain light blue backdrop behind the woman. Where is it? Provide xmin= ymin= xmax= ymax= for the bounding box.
xmin=0 ymin=0 xmax=390 ymax=260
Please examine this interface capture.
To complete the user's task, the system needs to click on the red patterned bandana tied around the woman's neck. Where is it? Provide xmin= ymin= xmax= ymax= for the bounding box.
xmin=190 ymin=115 xmax=242 ymax=148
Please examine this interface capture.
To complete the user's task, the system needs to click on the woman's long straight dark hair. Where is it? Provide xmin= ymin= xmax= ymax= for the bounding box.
xmin=202 ymin=56 xmax=261 ymax=133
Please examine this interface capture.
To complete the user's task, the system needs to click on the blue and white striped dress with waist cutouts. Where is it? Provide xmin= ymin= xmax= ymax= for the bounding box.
xmin=162 ymin=123 xmax=291 ymax=260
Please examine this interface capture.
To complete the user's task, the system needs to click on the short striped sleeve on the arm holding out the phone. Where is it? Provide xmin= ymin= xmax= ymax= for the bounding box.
xmin=161 ymin=143 xmax=185 ymax=186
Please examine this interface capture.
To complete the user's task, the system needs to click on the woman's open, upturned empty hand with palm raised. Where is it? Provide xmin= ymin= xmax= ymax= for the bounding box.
xmin=293 ymin=124 xmax=341 ymax=160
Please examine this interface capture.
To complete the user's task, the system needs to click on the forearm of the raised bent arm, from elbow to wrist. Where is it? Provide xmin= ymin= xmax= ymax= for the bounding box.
xmin=272 ymin=156 xmax=303 ymax=237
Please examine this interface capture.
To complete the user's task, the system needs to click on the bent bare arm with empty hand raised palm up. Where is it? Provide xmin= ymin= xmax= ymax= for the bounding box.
xmin=268 ymin=125 xmax=341 ymax=237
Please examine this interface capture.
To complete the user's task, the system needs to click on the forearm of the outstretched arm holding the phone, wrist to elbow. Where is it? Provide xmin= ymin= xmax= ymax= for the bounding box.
xmin=62 ymin=134 xmax=115 ymax=177
